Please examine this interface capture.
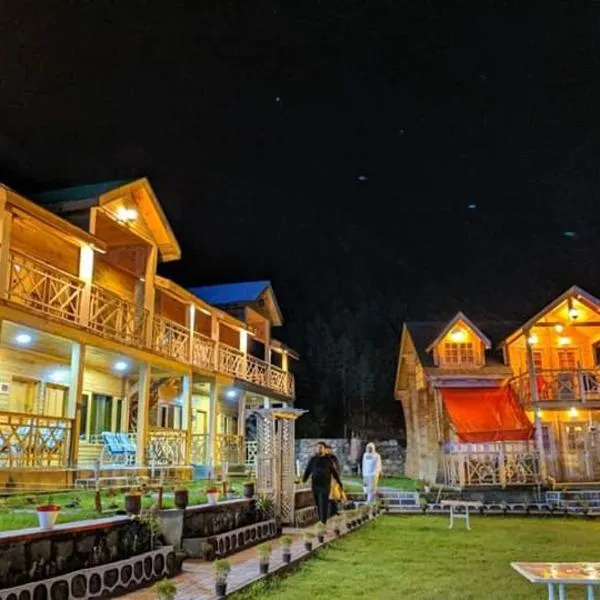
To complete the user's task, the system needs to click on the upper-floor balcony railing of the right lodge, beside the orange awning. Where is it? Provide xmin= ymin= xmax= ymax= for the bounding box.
xmin=510 ymin=369 xmax=600 ymax=408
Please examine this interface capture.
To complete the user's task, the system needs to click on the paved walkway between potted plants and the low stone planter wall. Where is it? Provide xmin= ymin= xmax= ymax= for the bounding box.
xmin=122 ymin=529 xmax=333 ymax=600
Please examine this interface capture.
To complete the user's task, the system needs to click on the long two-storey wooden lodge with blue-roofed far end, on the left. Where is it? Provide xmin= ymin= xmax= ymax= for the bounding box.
xmin=0 ymin=179 xmax=297 ymax=486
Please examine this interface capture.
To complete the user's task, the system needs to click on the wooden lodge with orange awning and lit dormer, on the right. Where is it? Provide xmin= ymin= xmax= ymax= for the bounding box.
xmin=395 ymin=287 xmax=600 ymax=488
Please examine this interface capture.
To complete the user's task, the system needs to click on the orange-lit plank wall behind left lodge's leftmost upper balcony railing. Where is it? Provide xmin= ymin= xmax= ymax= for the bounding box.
xmin=11 ymin=216 xmax=79 ymax=275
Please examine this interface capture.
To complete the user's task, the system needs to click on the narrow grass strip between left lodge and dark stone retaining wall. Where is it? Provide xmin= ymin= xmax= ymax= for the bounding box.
xmin=0 ymin=481 xmax=242 ymax=531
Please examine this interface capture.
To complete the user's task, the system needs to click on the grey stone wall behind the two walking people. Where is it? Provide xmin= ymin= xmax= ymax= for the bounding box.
xmin=296 ymin=438 xmax=406 ymax=476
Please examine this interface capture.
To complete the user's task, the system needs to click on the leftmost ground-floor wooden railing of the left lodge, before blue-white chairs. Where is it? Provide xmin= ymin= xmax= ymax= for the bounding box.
xmin=0 ymin=412 xmax=73 ymax=469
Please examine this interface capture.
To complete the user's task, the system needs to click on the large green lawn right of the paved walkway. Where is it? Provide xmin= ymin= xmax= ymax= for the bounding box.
xmin=235 ymin=516 xmax=600 ymax=600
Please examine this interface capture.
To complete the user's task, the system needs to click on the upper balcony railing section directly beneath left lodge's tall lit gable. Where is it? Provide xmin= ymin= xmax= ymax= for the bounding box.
xmin=89 ymin=285 xmax=148 ymax=346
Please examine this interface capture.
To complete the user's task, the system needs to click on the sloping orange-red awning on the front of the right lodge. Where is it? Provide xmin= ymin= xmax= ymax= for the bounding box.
xmin=442 ymin=386 xmax=533 ymax=443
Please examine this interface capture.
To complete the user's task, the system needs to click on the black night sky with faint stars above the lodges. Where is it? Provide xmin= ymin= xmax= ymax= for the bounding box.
xmin=0 ymin=0 xmax=600 ymax=432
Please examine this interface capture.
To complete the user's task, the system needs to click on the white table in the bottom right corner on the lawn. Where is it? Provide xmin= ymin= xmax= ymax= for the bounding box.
xmin=510 ymin=562 xmax=600 ymax=600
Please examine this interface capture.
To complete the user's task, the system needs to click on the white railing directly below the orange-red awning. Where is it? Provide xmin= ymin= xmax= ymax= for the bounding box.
xmin=443 ymin=442 xmax=540 ymax=487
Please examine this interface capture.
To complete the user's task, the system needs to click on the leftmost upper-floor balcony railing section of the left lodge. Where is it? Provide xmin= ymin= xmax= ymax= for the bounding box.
xmin=8 ymin=252 xmax=83 ymax=322
